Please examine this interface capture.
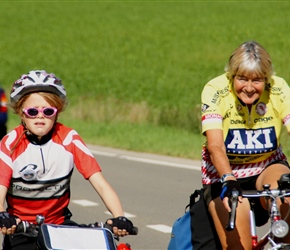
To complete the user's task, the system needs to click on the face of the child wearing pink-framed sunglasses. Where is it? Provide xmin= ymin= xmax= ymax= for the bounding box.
xmin=21 ymin=93 xmax=56 ymax=139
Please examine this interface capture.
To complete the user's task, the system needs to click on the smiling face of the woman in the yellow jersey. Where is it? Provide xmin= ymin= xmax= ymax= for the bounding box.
xmin=234 ymin=76 xmax=265 ymax=105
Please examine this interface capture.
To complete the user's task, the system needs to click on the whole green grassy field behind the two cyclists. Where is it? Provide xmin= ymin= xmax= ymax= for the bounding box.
xmin=0 ymin=0 xmax=290 ymax=159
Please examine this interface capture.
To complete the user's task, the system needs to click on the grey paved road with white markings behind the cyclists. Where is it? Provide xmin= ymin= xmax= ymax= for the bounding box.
xmin=0 ymin=145 xmax=268 ymax=250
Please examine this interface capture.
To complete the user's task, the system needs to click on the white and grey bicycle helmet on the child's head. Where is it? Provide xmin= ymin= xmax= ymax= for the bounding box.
xmin=10 ymin=70 xmax=66 ymax=103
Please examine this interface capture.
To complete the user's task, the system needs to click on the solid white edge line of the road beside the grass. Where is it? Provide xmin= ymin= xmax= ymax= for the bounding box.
xmin=91 ymin=150 xmax=201 ymax=171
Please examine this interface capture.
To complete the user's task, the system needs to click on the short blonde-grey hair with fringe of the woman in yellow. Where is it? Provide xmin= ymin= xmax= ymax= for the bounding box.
xmin=225 ymin=41 xmax=274 ymax=82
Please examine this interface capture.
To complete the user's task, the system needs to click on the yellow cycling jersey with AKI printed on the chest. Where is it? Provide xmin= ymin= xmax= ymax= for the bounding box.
xmin=201 ymin=74 xmax=290 ymax=184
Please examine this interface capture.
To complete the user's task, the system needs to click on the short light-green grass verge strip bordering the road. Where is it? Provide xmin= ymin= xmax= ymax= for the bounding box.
xmin=9 ymin=110 xmax=202 ymax=159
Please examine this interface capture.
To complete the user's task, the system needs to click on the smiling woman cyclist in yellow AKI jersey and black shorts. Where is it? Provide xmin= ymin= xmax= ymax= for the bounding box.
xmin=201 ymin=41 xmax=290 ymax=250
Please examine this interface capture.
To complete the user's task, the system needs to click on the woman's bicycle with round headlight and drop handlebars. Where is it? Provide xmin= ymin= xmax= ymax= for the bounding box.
xmin=226 ymin=174 xmax=290 ymax=250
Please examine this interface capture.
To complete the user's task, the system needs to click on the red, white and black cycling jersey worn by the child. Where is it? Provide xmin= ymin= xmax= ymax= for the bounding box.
xmin=0 ymin=123 xmax=101 ymax=224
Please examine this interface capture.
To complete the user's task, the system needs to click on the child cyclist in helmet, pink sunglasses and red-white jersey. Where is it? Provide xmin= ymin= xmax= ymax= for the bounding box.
xmin=0 ymin=70 xmax=133 ymax=249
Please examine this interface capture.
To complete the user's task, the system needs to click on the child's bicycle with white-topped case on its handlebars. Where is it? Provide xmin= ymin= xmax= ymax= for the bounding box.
xmin=15 ymin=215 xmax=138 ymax=250
